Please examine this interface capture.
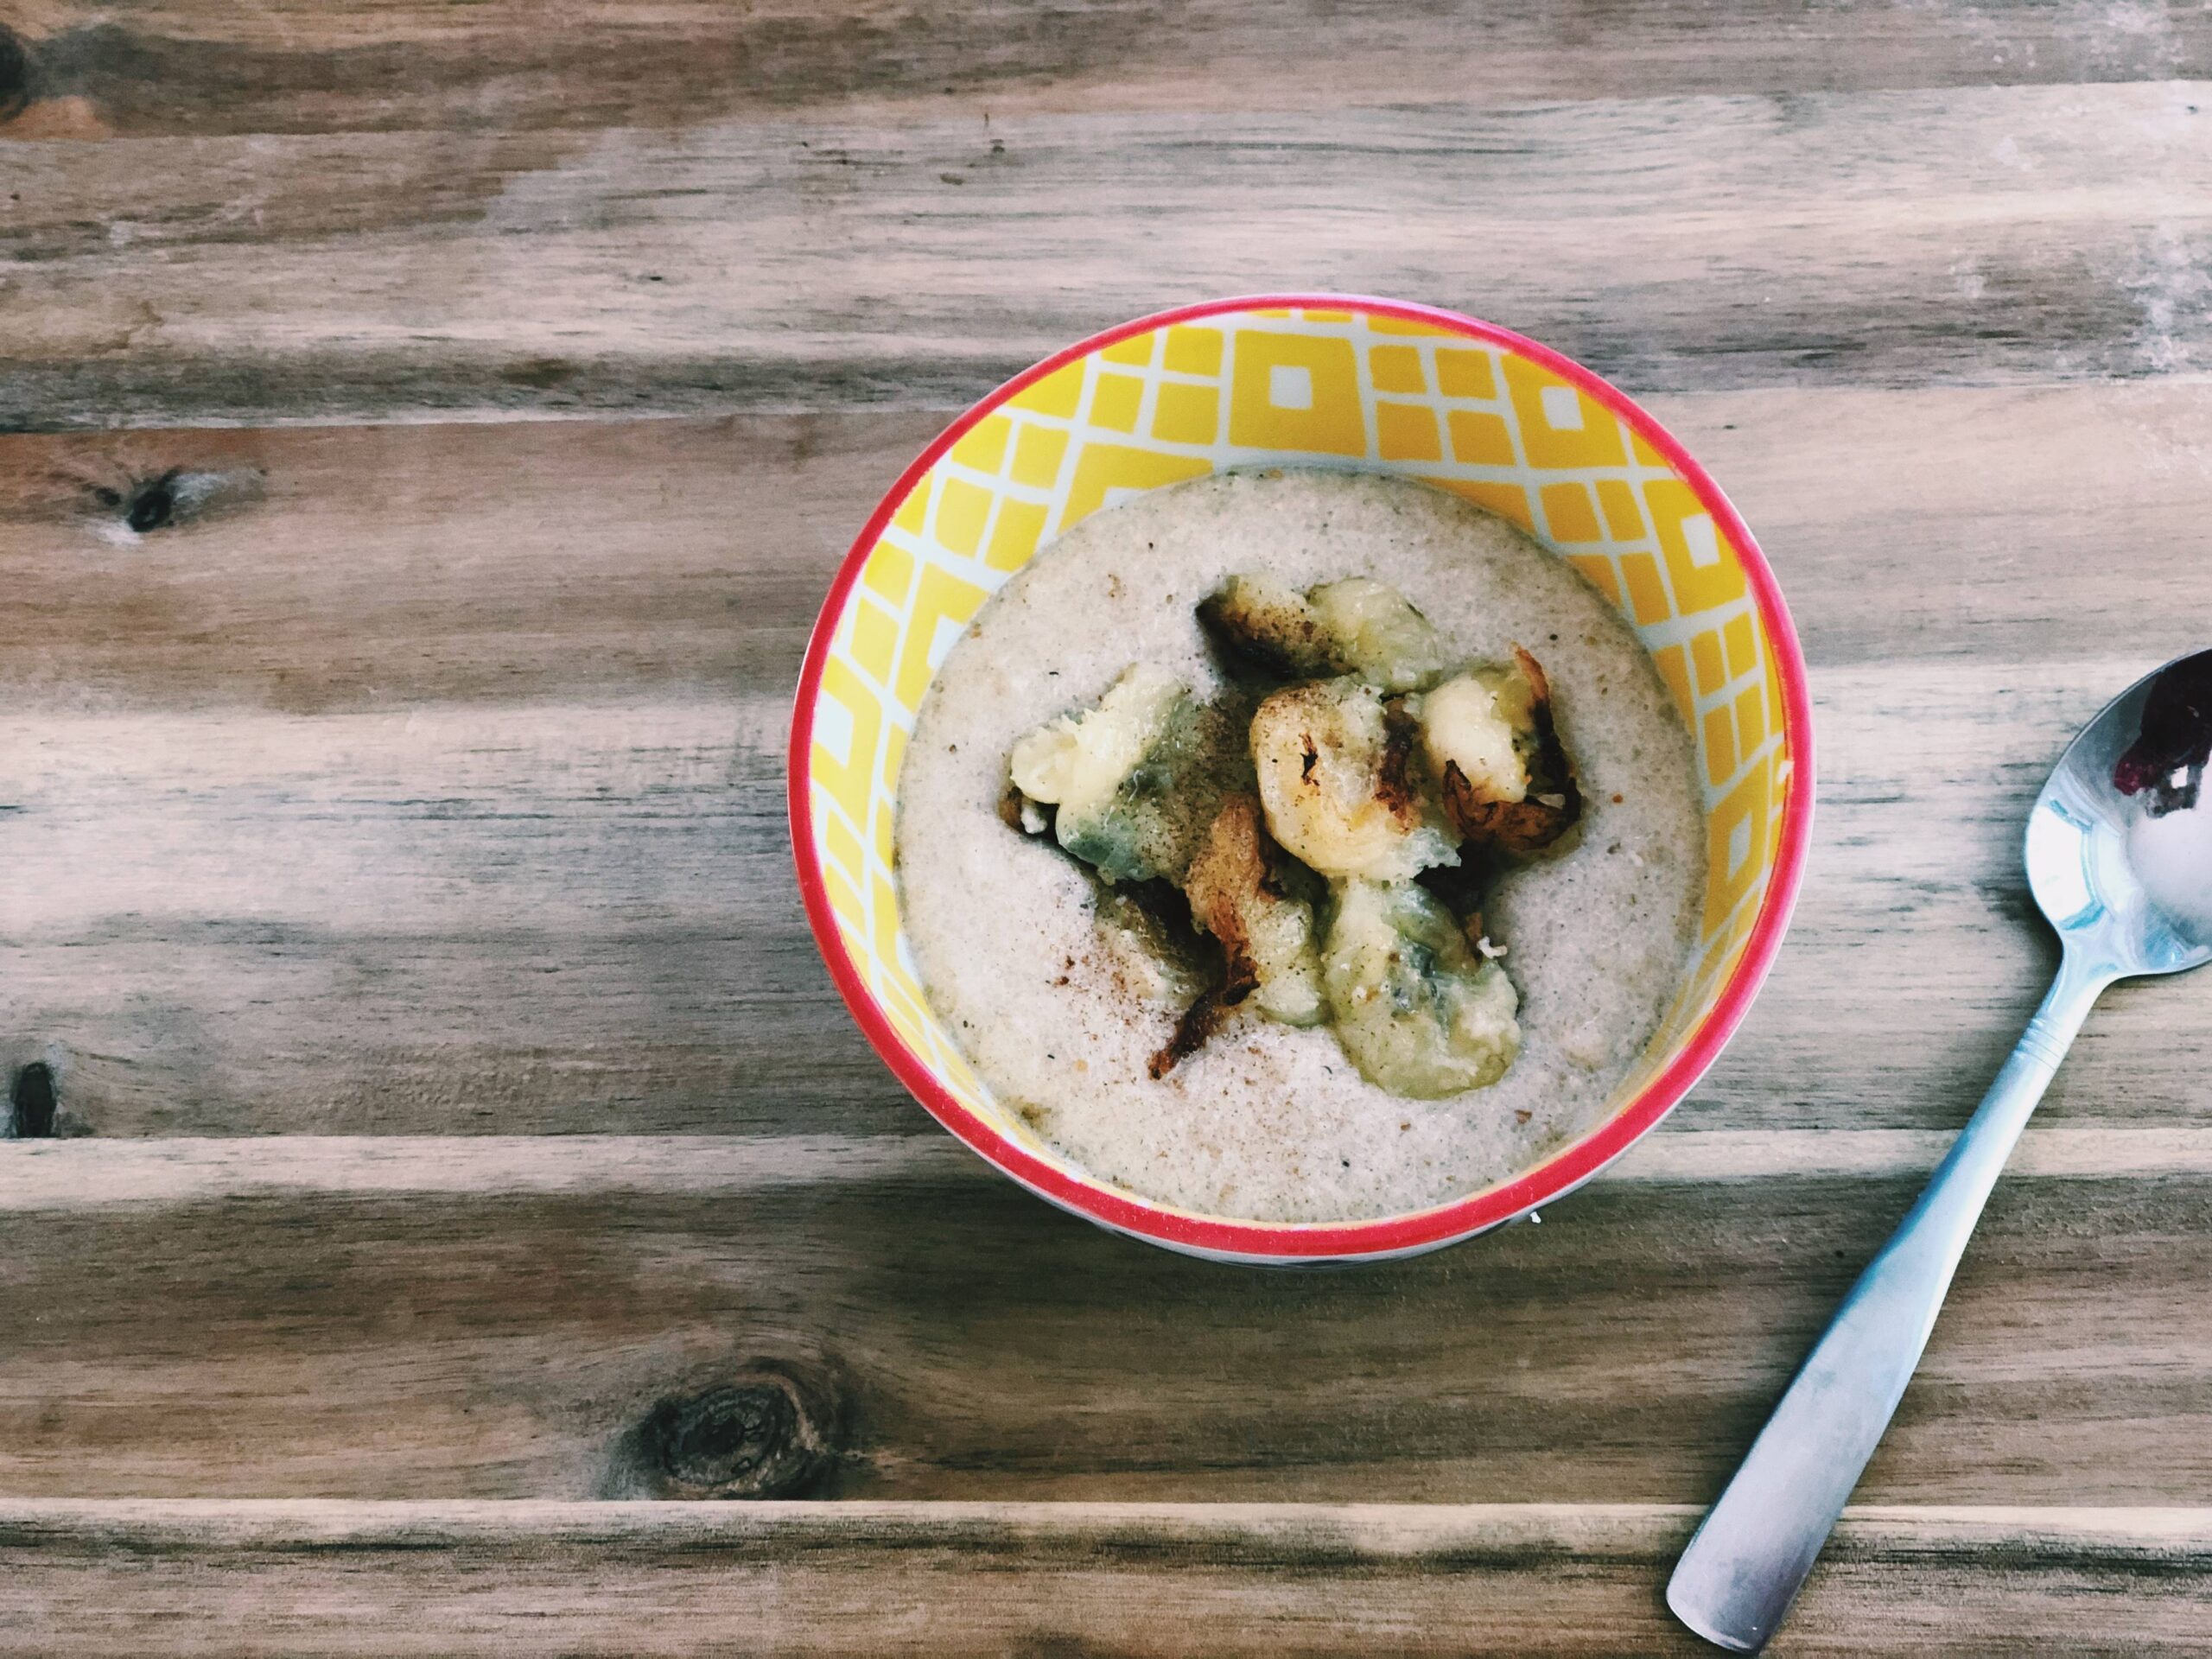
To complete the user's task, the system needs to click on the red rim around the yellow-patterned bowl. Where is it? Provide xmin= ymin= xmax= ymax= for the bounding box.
xmin=790 ymin=294 xmax=1814 ymax=1261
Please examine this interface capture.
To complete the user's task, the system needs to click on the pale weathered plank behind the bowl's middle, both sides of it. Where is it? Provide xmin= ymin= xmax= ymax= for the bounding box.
xmin=0 ymin=661 xmax=2212 ymax=1135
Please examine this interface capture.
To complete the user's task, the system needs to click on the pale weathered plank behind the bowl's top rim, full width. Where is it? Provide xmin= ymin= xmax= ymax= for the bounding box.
xmin=0 ymin=84 xmax=2212 ymax=429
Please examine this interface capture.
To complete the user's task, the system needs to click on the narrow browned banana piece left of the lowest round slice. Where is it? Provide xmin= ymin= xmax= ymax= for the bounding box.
xmin=1184 ymin=794 xmax=1325 ymax=1027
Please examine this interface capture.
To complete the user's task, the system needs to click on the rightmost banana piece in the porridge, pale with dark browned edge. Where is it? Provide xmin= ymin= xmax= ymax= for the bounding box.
xmin=1421 ymin=646 xmax=1581 ymax=856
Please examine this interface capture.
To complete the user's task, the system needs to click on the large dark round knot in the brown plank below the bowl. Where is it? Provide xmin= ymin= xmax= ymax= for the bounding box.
xmin=621 ymin=1365 xmax=841 ymax=1497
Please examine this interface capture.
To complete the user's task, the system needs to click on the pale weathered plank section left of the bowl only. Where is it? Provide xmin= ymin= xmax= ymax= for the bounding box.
xmin=0 ymin=699 xmax=844 ymax=1135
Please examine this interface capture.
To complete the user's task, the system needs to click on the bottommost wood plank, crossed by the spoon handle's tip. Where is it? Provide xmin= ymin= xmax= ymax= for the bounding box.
xmin=0 ymin=1500 xmax=2212 ymax=1659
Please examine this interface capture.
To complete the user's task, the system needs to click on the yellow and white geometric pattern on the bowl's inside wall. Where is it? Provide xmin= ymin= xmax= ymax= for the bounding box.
xmin=807 ymin=309 xmax=1792 ymax=1176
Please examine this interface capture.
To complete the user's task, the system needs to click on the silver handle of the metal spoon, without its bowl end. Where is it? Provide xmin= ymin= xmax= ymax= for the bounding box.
xmin=1666 ymin=949 xmax=2114 ymax=1652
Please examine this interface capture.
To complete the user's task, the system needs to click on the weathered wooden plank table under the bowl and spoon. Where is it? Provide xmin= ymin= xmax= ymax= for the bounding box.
xmin=0 ymin=0 xmax=2212 ymax=1655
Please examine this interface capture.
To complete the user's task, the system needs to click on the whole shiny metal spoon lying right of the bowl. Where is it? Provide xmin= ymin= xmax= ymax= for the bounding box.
xmin=1666 ymin=651 xmax=2212 ymax=1652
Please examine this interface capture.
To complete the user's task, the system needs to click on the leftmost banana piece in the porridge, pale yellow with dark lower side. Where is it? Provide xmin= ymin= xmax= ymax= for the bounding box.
xmin=1007 ymin=664 xmax=1249 ymax=882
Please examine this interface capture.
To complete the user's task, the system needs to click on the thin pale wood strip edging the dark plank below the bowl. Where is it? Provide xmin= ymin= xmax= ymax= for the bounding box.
xmin=0 ymin=1123 xmax=2212 ymax=1212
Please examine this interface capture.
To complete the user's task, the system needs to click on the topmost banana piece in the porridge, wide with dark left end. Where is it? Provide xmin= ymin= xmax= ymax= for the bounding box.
xmin=1199 ymin=573 xmax=1449 ymax=692
